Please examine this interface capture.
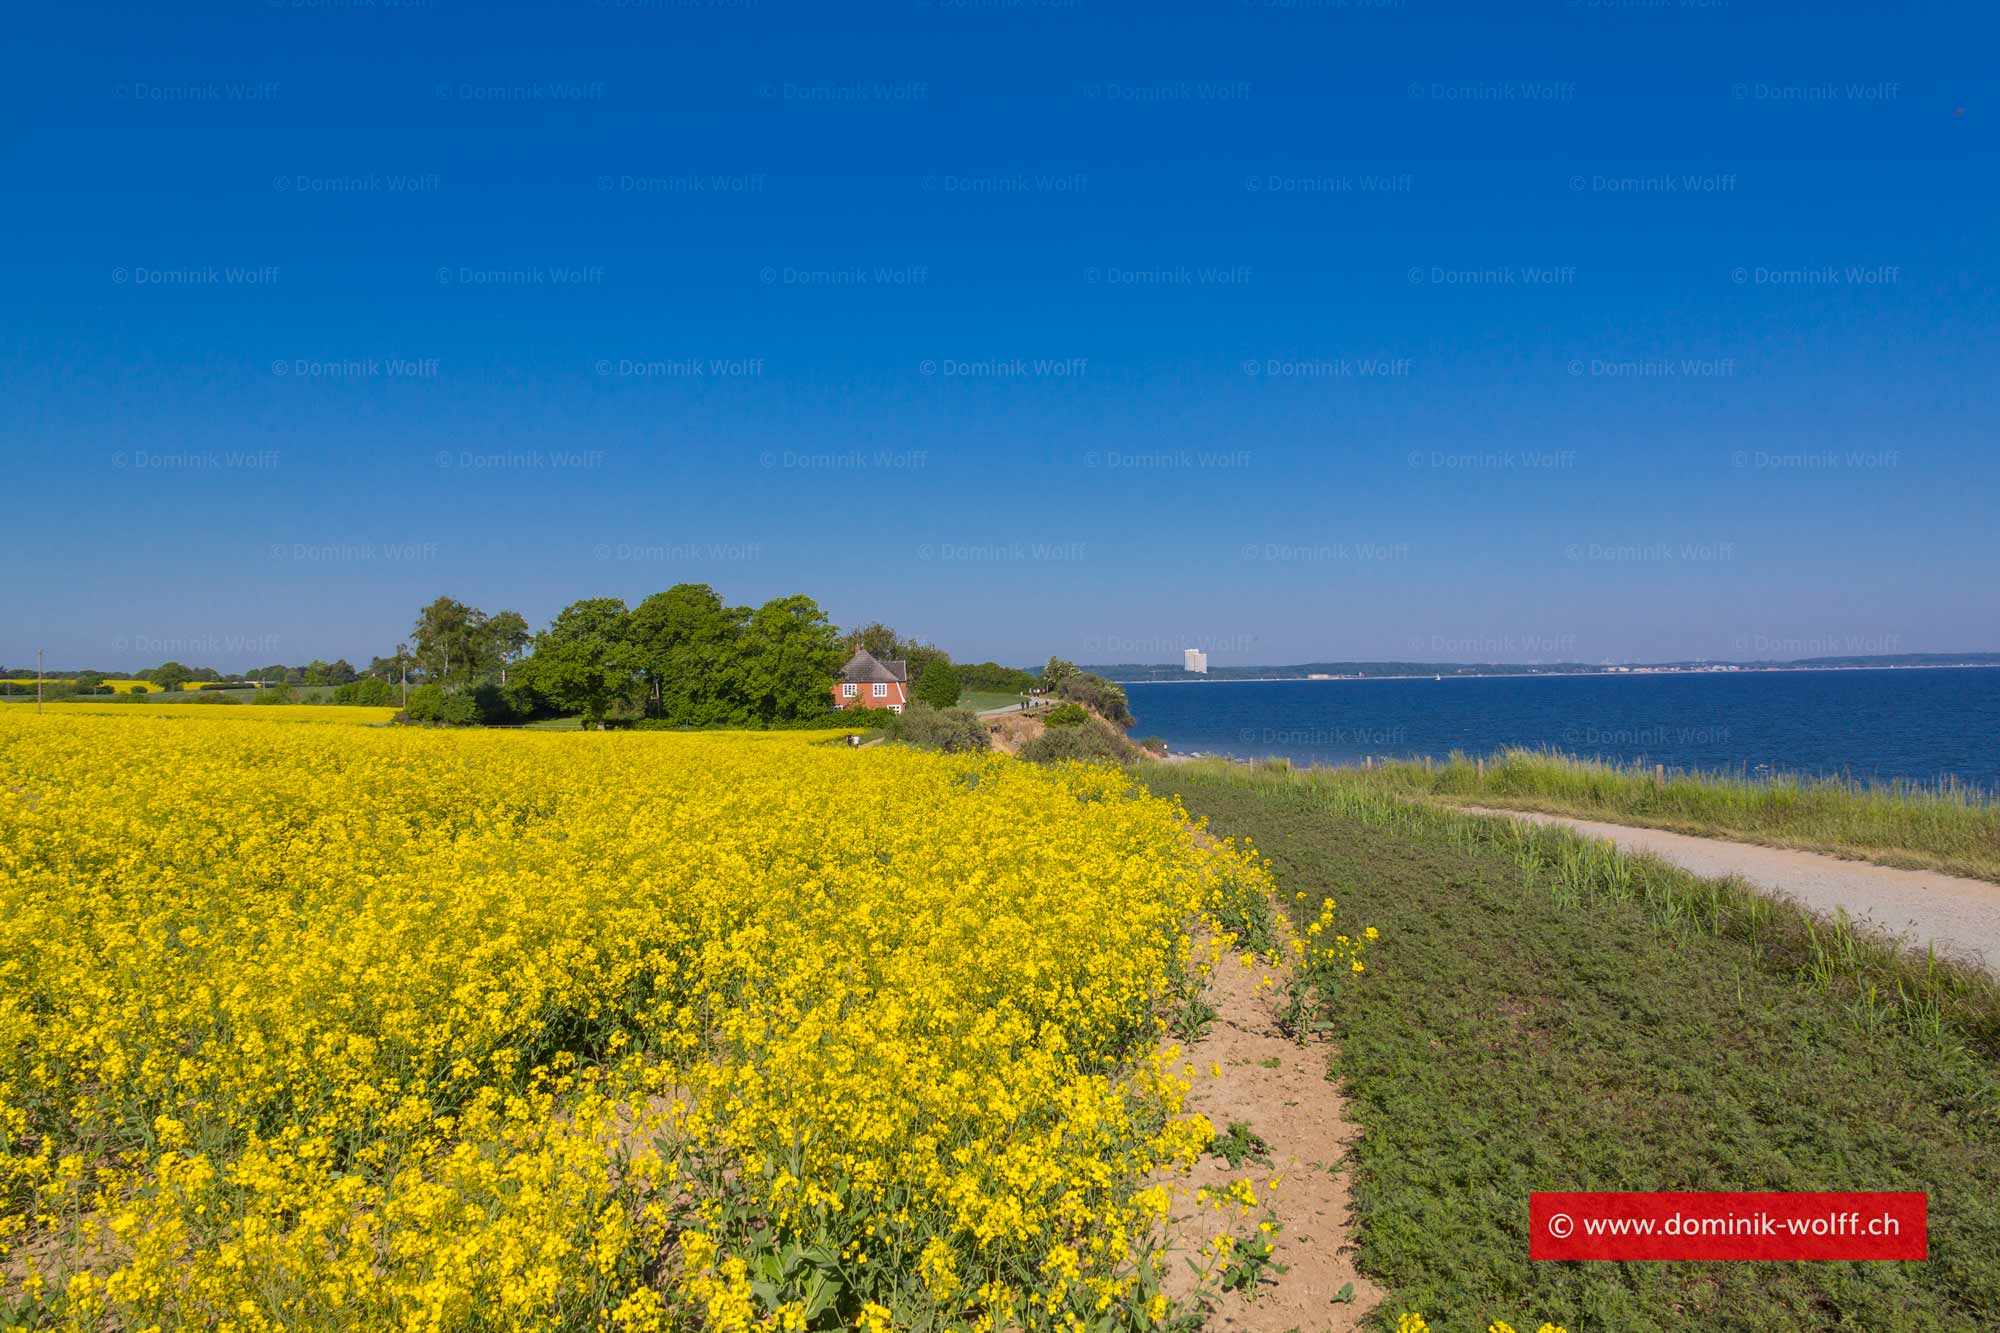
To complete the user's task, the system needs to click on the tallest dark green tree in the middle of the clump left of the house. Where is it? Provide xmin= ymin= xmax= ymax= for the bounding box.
xmin=630 ymin=582 xmax=750 ymax=727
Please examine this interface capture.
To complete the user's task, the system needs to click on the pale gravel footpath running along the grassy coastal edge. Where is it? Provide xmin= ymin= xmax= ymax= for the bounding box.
xmin=1458 ymin=805 xmax=2000 ymax=971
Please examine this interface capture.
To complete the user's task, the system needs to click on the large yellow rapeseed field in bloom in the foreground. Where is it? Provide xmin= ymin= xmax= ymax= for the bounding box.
xmin=0 ymin=705 xmax=1328 ymax=1333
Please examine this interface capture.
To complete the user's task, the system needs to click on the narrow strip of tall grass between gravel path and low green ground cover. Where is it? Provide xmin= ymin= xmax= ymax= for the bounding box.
xmin=1142 ymin=755 xmax=2000 ymax=1059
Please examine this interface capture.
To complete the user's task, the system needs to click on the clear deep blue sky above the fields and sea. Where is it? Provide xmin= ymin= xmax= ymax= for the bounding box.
xmin=0 ymin=0 xmax=2000 ymax=669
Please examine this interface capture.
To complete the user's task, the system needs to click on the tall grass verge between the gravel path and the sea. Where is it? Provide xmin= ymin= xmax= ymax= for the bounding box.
xmin=1360 ymin=751 xmax=2000 ymax=881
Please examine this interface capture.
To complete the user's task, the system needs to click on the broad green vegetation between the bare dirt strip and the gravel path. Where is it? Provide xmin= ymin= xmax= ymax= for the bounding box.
xmin=1140 ymin=765 xmax=2000 ymax=1333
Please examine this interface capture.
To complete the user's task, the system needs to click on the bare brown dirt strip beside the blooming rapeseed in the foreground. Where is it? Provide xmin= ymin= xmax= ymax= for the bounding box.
xmin=1168 ymin=940 xmax=1382 ymax=1333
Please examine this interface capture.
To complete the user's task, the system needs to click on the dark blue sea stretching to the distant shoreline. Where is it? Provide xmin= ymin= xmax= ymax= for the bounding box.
xmin=1126 ymin=669 xmax=2000 ymax=791
